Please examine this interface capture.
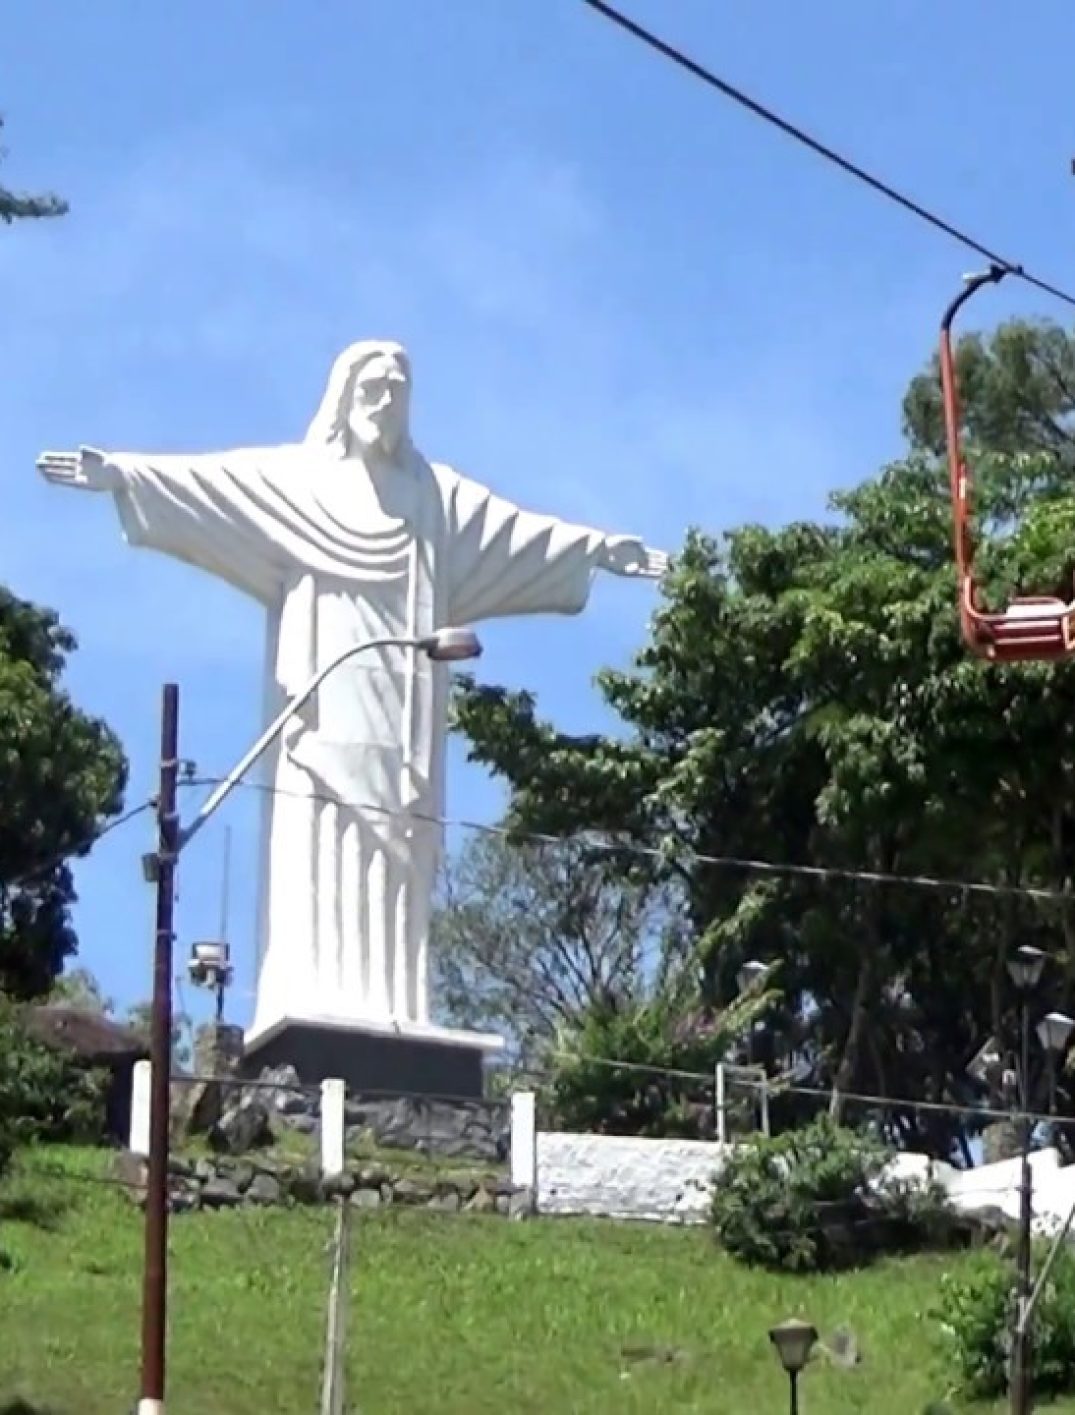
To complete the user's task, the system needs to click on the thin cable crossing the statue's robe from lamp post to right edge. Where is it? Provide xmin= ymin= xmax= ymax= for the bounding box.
xmin=188 ymin=777 xmax=1075 ymax=906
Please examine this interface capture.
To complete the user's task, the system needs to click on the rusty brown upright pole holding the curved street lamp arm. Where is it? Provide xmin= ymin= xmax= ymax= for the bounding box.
xmin=137 ymin=683 xmax=180 ymax=1415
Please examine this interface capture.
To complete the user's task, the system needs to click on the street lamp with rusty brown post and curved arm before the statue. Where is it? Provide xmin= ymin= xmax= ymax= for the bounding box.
xmin=137 ymin=628 xmax=481 ymax=1415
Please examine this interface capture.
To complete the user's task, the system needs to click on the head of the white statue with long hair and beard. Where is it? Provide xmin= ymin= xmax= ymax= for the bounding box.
xmin=306 ymin=340 xmax=410 ymax=457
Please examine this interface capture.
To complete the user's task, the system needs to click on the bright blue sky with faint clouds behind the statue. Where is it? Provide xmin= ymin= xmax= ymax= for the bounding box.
xmin=0 ymin=0 xmax=1075 ymax=1022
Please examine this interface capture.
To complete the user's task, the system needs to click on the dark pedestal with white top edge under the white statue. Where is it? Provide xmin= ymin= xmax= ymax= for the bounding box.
xmin=242 ymin=1019 xmax=496 ymax=1099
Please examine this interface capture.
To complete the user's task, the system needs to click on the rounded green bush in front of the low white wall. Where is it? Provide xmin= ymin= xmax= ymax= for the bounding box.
xmin=711 ymin=1116 xmax=956 ymax=1272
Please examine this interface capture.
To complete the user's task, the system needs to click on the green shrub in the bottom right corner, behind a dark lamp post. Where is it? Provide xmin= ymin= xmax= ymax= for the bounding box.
xmin=929 ymin=1247 xmax=1075 ymax=1397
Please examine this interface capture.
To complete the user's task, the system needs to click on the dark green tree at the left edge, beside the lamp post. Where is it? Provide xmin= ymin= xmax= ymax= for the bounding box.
xmin=0 ymin=589 xmax=126 ymax=998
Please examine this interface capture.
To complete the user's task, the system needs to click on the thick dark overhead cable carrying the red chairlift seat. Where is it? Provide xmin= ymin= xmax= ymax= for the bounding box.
xmin=583 ymin=0 xmax=1075 ymax=306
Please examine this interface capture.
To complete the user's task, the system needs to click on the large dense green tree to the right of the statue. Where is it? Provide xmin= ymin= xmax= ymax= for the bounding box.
xmin=444 ymin=323 xmax=1075 ymax=1156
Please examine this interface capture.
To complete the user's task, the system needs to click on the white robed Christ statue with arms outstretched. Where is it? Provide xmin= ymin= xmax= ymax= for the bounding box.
xmin=38 ymin=341 xmax=666 ymax=1036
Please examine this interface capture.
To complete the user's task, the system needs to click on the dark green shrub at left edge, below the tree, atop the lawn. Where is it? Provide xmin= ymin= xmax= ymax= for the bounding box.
xmin=0 ymin=1000 xmax=105 ymax=1174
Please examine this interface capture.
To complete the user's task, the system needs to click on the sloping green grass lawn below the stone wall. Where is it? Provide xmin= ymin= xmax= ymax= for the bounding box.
xmin=0 ymin=1150 xmax=1075 ymax=1415
